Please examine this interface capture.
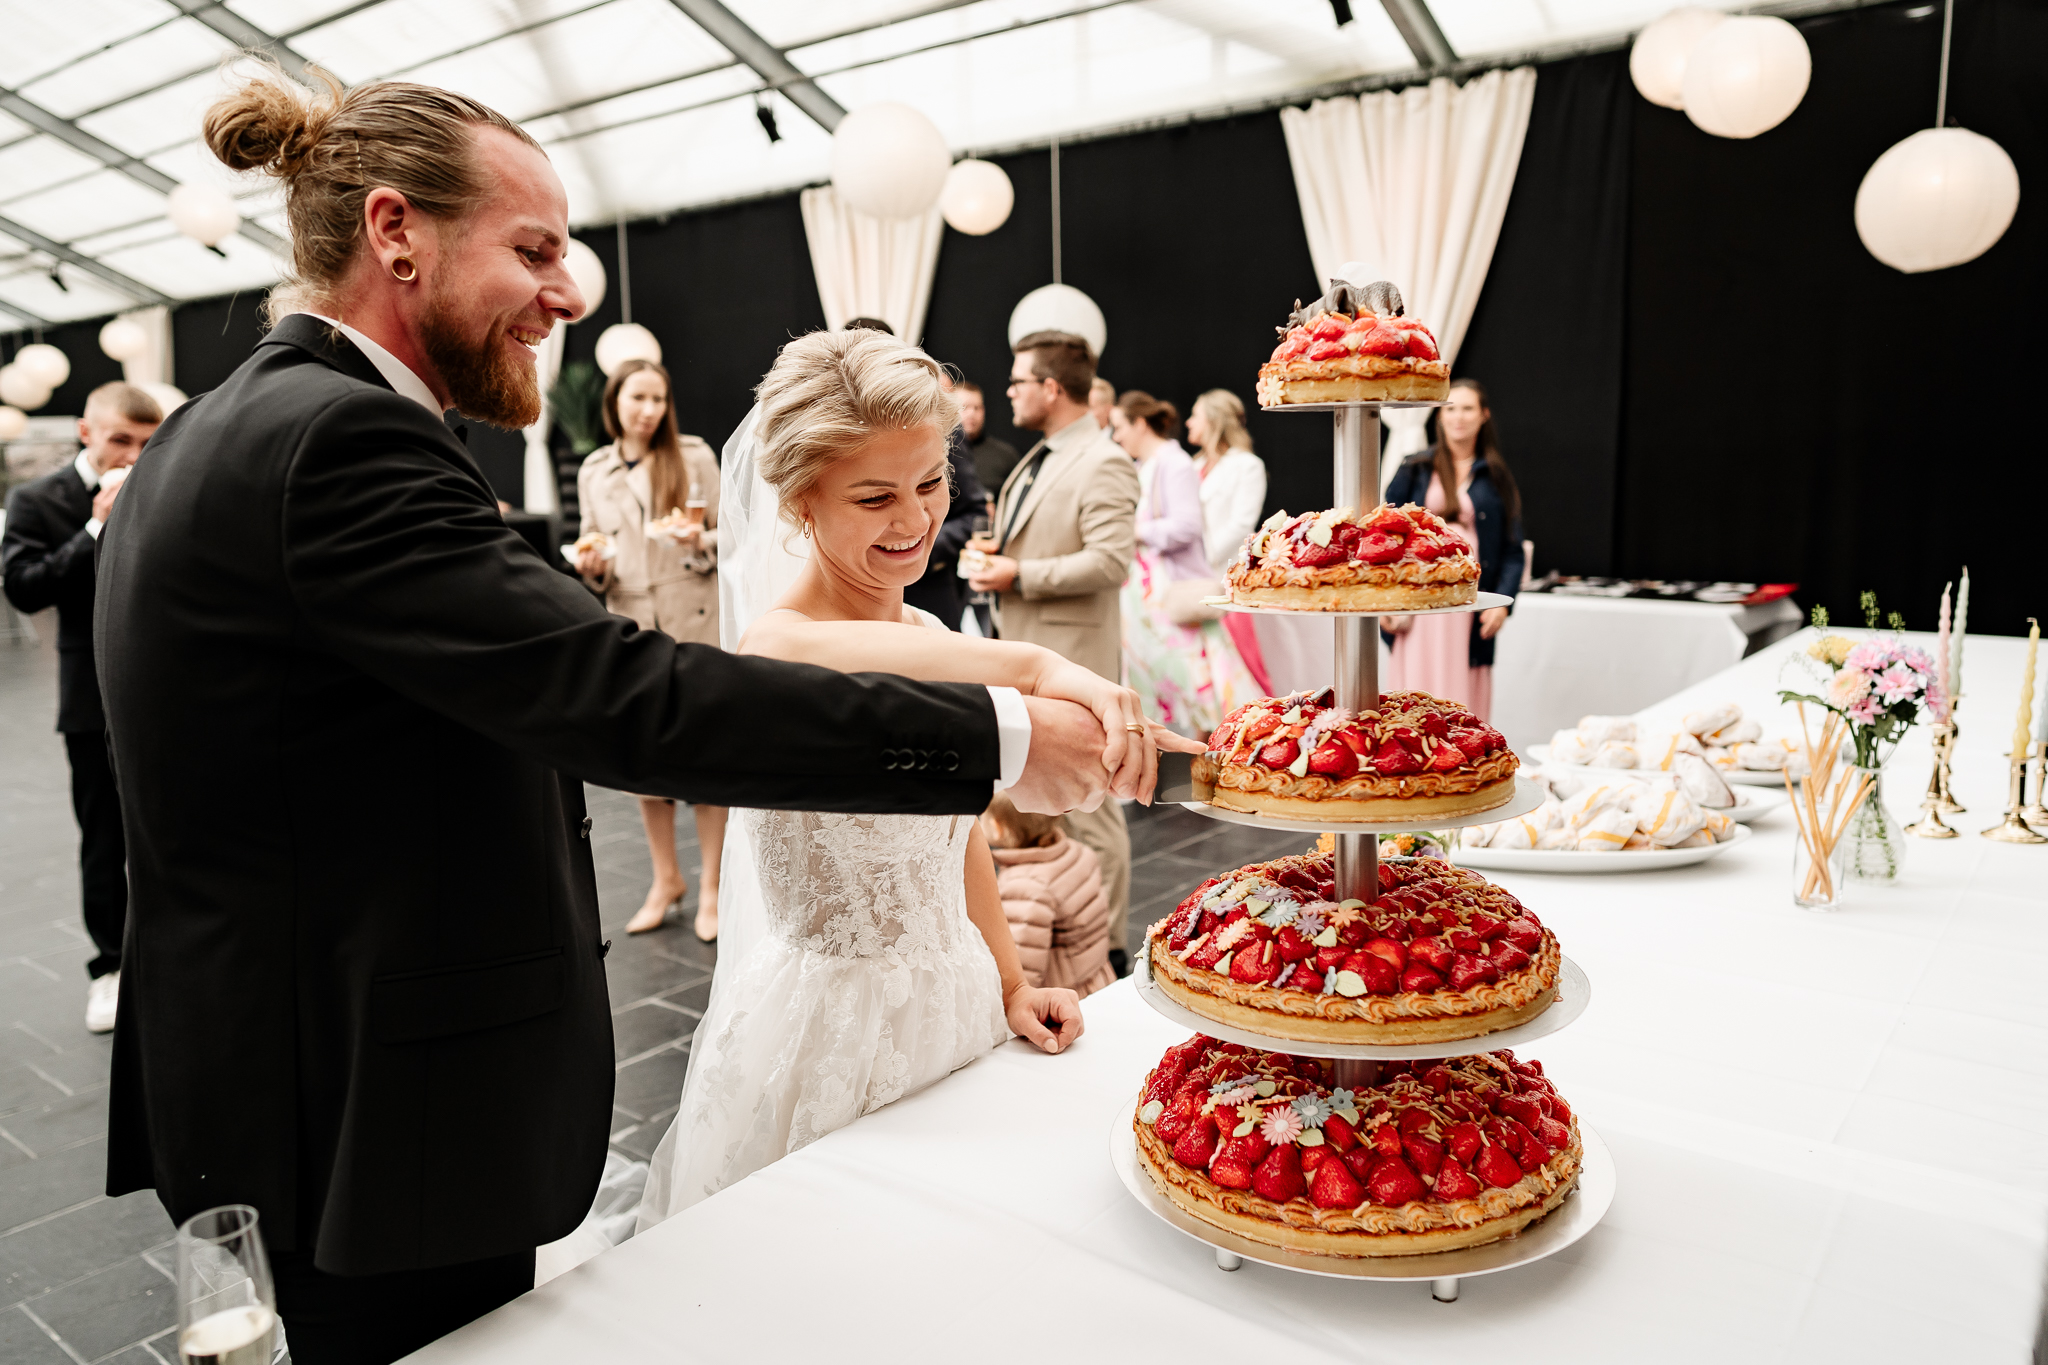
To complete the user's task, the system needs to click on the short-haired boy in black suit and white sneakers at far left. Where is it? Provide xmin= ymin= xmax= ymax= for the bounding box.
xmin=0 ymin=383 xmax=164 ymax=1033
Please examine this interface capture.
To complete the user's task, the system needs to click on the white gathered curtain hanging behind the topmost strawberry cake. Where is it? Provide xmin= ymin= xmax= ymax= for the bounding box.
xmin=1280 ymin=65 xmax=1536 ymax=478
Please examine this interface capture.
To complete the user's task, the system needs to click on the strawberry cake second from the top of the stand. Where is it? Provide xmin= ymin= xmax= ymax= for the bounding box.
xmin=1225 ymin=503 xmax=1479 ymax=612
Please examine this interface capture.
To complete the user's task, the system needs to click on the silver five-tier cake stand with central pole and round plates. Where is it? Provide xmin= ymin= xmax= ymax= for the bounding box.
xmin=1110 ymin=403 xmax=1614 ymax=1304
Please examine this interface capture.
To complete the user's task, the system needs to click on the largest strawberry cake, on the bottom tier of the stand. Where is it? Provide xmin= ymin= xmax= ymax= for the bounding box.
xmin=1133 ymin=1036 xmax=1583 ymax=1257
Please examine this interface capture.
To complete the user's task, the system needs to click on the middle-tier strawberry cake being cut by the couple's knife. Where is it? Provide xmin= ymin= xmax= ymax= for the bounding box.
xmin=1192 ymin=688 xmax=1522 ymax=823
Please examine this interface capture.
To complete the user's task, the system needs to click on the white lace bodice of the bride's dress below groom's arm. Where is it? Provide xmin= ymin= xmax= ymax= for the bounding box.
xmin=741 ymin=810 xmax=979 ymax=966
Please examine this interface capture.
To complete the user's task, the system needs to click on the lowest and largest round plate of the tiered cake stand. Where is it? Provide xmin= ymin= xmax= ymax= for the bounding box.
xmin=1110 ymin=1103 xmax=1614 ymax=1304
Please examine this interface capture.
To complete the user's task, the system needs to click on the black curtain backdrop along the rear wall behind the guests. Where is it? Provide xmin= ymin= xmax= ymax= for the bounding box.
xmin=8 ymin=0 xmax=2048 ymax=632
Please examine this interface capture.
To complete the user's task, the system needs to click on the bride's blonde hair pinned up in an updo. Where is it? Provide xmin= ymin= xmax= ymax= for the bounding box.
xmin=754 ymin=329 xmax=961 ymax=524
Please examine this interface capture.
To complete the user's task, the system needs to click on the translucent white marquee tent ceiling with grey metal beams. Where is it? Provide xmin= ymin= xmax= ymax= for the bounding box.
xmin=0 ymin=0 xmax=1818 ymax=329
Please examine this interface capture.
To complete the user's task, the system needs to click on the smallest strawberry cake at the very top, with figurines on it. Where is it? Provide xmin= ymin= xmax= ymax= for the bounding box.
xmin=1257 ymin=280 xmax=1450 ymax=407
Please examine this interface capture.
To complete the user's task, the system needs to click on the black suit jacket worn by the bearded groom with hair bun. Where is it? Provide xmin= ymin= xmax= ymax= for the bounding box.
xmin=96 ymin=315 xmax=999 ymax=1275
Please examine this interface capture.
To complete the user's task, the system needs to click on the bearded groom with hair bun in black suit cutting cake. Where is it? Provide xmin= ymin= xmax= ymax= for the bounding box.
xmin=96 ymin=72 xmax=1149 ymax=1365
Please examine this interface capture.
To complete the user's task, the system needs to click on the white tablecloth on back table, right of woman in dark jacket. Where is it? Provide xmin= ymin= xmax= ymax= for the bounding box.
xmin=1491 ymin=593 xmax=1800 ymax=747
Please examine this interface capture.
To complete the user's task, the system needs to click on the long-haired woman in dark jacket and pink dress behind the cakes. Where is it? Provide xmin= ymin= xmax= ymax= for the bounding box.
xmin=1380 ymin=379 xmax=1522 ymax=720
